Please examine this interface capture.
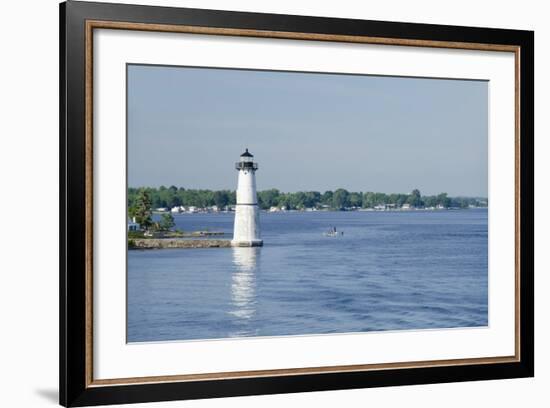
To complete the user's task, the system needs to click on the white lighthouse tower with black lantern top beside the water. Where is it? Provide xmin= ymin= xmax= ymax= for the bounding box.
xmin=231 ymin=149 xmax=263 ymax=247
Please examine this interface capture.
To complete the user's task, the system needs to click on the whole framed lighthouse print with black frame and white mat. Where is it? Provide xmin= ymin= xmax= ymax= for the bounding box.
xmin=60 ymin=1 xmax=534 ymax=406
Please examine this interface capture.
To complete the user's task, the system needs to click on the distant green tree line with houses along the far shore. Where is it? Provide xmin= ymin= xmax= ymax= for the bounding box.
xmin=128 ymin=186 xmax=487 ymax=212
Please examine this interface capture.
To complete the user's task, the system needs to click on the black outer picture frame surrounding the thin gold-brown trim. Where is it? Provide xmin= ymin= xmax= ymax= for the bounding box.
xmin=59 ymin=1 xmax=534 ymax=406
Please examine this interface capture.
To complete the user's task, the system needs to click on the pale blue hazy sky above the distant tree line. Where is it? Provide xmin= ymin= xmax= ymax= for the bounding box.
xmin=128 ymin=65 xmax=489 ymax=197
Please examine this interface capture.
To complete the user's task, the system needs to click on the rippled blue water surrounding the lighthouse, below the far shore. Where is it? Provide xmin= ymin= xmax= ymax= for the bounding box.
xmin=128 ymin=209 xmax=488 ymax=342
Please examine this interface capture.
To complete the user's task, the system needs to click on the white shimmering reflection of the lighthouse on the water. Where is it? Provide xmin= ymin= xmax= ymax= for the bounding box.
xmin=229 ymin=247 xmax=260 ymax=326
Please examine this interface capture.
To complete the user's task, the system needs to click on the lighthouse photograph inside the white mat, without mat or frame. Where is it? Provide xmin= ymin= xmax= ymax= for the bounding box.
xmin=126 ymin=63 xmax=492 ymax=343
